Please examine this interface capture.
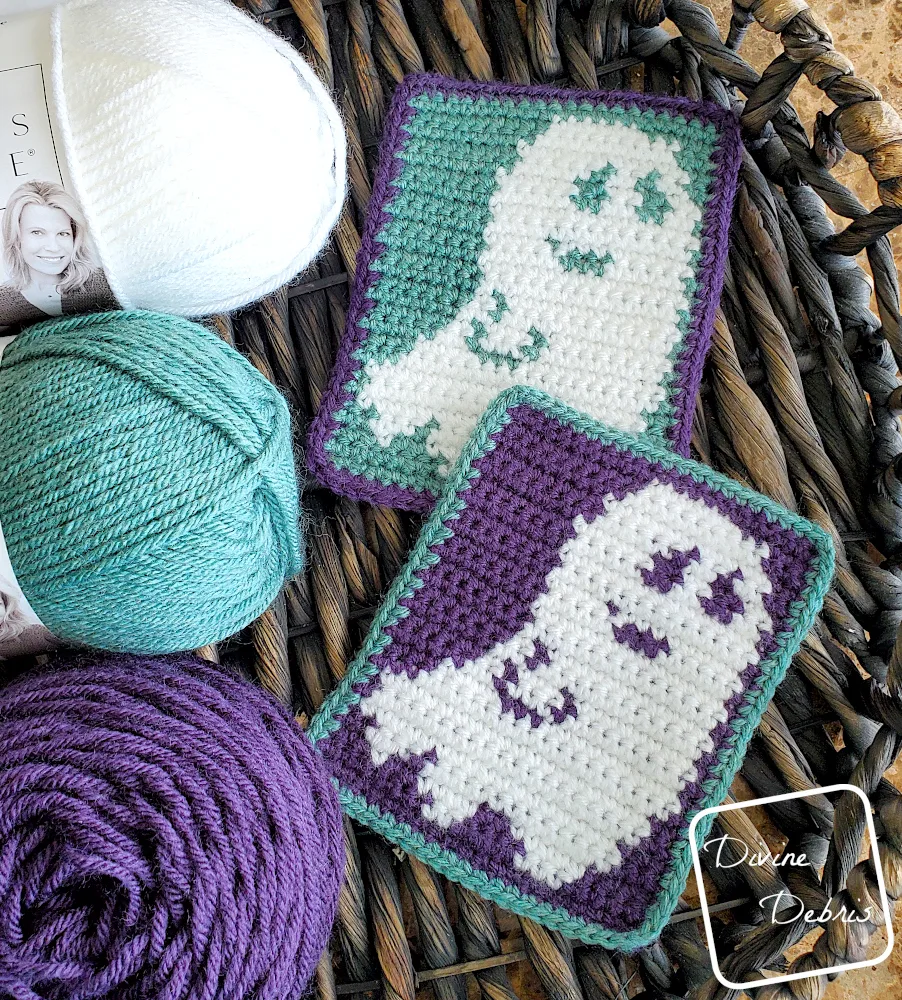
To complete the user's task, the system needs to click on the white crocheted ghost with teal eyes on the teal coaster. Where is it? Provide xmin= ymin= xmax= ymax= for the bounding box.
xmin=359 ymin=117 xmax=701 ymax=473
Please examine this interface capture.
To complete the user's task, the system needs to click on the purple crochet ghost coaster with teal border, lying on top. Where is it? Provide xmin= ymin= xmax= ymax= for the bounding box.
xmin=310 ymin=387 xmax=833 ymax=948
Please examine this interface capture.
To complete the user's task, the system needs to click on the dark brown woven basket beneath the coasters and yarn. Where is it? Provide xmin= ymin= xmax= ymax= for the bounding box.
xmin=222 ymin=0 xmax=902 ymax=1000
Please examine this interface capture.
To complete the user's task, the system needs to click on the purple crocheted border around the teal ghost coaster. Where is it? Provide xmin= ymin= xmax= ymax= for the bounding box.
xmin=307 ymin=73 xmax=742 ymax=513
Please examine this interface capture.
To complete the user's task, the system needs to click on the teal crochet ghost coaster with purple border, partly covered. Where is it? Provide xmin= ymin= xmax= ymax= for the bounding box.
xmin=309 ymin=76 xmax=741 ymax=511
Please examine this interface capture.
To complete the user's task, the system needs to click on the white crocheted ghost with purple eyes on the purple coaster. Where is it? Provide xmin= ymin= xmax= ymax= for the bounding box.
xmin=360 ymin=482 xmax=772 ymax=888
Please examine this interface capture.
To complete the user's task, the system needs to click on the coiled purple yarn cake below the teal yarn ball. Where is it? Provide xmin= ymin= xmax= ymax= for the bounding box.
xmin=0 ymin=655 xmax=344 ymax=1000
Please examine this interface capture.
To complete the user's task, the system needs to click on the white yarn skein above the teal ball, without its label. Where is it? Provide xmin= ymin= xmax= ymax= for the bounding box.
xmin=51 ymin=0 xmax=346 ymax=316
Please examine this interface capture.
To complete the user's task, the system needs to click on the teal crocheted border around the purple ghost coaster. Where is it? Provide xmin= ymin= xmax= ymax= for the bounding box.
xmin=308 ymin=386 xmax=834 ymax=951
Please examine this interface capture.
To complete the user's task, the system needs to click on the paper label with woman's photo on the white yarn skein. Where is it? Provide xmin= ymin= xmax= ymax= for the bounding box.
xmin=0 ymin=10 xmax=119 ymax=331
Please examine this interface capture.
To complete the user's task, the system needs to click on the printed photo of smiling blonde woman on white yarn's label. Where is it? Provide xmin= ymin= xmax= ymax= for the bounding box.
xmin=0 ymin=181 xmax=118 ymax=325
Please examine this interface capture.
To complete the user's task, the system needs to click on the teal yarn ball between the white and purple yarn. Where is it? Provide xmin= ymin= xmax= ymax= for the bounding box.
xmin=0 ymin=312 xmax=303 ymax=653
